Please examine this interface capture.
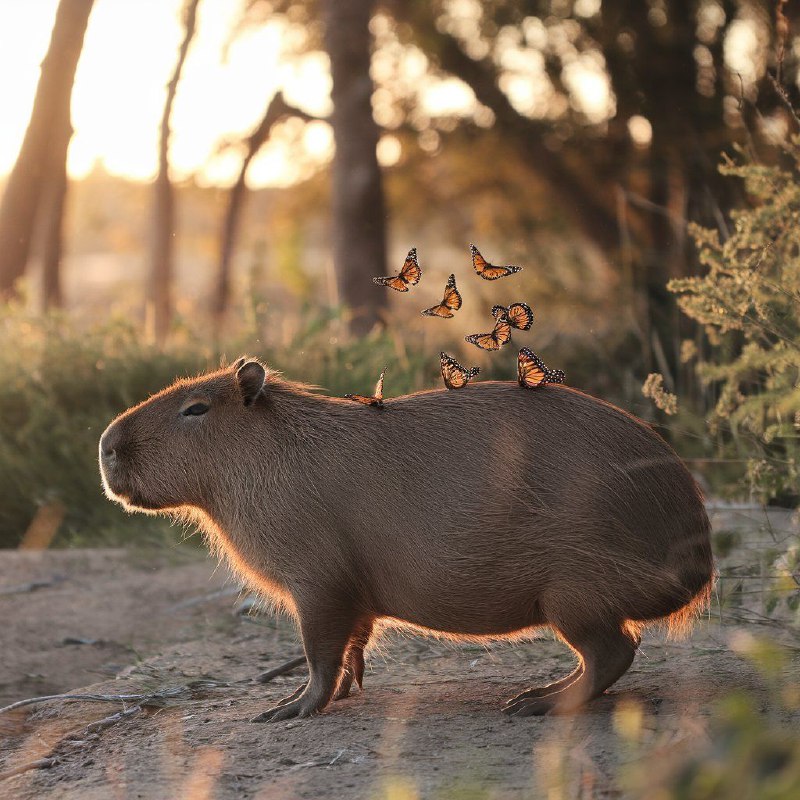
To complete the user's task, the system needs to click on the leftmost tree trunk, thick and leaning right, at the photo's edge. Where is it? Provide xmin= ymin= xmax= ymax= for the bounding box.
xmin=0 ymin=0 xmax=94 ymax=298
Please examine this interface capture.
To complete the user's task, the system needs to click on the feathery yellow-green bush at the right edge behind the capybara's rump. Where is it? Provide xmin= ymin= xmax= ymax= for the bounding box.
xmin=669 ymin=146 xmax=800 ymax=502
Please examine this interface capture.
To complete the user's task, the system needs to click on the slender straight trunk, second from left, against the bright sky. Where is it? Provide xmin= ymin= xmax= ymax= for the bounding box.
xmin=147 ymin=0 xmax=200 ymax=343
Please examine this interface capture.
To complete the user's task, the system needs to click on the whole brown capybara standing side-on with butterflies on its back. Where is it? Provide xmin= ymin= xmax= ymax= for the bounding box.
xmin=100 ymin=359 xmax=713 ymax=721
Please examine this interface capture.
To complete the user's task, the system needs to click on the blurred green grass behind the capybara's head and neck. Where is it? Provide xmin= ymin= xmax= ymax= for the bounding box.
xmin=0 ymin=306 xmax=438 ymax=547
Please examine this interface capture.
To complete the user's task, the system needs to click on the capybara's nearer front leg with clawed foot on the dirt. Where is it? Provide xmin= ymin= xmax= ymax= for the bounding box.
xmin=252 ymin=600 xmax=358 ymax=722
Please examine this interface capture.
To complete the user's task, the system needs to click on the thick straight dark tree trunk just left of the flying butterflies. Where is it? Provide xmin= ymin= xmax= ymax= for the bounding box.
xmin=325 ymin=0 xmax=387 ymax=334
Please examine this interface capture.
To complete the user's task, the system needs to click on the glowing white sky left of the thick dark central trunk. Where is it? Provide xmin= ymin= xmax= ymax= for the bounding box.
xmin=0 ymin=0 xmax=332 ymax=186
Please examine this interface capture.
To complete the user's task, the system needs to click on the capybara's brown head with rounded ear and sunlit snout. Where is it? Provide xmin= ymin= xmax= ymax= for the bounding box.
xmin=100 ymin=359 xmax=266 ymax=511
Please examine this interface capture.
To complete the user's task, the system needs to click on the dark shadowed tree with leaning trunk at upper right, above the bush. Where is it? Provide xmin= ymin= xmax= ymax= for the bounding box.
xmin=388 ymin=0 xmax=797 ymax=383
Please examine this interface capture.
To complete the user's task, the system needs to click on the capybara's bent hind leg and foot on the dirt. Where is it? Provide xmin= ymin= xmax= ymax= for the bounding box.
xmin=505 ymin=623 xmax=638 ymax=717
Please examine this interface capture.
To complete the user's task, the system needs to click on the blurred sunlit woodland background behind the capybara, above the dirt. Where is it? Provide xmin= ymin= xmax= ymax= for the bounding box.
xmin=0 ymin=0 xmax=800 ymax=546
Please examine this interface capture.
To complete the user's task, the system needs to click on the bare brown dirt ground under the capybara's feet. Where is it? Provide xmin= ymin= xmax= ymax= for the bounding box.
xmin=0 ymin=510 xmax=800 ymax=800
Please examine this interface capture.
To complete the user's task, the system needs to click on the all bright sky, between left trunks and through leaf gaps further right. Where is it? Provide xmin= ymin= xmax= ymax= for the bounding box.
xmin=0 ymin=0 xmax=612 ymax=187
